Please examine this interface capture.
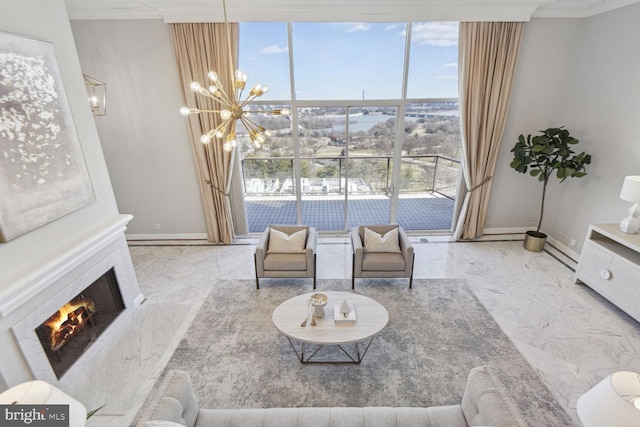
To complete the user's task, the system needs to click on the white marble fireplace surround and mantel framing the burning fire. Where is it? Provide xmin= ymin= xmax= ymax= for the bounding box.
xmin=0 ymin=215 xmax=144 ymax=389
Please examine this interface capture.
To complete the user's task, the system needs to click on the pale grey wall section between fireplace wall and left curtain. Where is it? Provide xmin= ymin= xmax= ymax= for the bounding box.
xmin=71 ymin=20 xmax=206 ymax=237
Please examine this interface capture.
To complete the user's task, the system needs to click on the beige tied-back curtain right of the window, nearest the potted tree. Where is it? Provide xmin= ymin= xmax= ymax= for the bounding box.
xmin=454 ymin=22 xmax=524 ymax=240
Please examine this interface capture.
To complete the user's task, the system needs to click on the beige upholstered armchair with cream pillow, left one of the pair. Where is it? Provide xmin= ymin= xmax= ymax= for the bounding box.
xmin=254 ymin=225 xmax=318 ymax=289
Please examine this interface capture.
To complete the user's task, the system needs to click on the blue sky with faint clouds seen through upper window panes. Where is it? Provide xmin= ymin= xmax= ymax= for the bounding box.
xmin=240 ymin=22 xmax=458 ymax=100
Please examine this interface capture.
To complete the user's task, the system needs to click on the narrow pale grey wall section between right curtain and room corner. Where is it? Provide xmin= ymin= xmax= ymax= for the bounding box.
xmin=486 ymin=19 xmax=582 ymax=236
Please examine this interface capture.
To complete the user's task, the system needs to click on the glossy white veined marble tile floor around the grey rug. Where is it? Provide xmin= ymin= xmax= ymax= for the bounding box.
xmin=84 ymin=236 xmax=640 ymax=426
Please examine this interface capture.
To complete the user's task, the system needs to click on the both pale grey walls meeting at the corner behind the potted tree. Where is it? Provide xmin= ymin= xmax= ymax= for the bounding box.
xmin=487 ymin=5 xmax=640 ymax=252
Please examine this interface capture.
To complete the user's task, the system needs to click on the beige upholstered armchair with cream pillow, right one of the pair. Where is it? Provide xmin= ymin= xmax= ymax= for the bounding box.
xmin=351 ymin=224 xmax=415 ymax=289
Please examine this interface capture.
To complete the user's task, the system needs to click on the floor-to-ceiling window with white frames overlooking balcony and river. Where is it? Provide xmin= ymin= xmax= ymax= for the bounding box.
xmin=238 ymin=23 xmax=460 ymax=232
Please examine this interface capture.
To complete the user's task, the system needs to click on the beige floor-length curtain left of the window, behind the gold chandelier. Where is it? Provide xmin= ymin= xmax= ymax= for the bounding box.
xmin=170 ymin=23 xmax=238 ymax=244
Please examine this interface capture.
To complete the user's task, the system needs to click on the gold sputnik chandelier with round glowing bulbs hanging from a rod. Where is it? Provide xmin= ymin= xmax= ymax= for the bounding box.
xmin=180 ymin=0 xmax=290 ymax=151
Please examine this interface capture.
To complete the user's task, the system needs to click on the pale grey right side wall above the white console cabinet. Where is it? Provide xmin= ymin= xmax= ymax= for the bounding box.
xmin=549 ymin=4 xmax=640 ymax=249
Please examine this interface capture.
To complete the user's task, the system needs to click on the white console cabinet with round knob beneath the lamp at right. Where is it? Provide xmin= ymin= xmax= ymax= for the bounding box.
xmin=574 ymin=224 xmax=640 ymax=321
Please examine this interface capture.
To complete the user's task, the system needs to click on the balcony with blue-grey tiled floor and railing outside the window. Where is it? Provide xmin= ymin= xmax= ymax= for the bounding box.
xmin=242 ymin=155 xmax=460 ymax=233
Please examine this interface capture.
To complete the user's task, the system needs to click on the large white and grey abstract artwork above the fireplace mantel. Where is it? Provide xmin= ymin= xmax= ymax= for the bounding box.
xmin=0 ymin=33 xmax=96 ymax=243
